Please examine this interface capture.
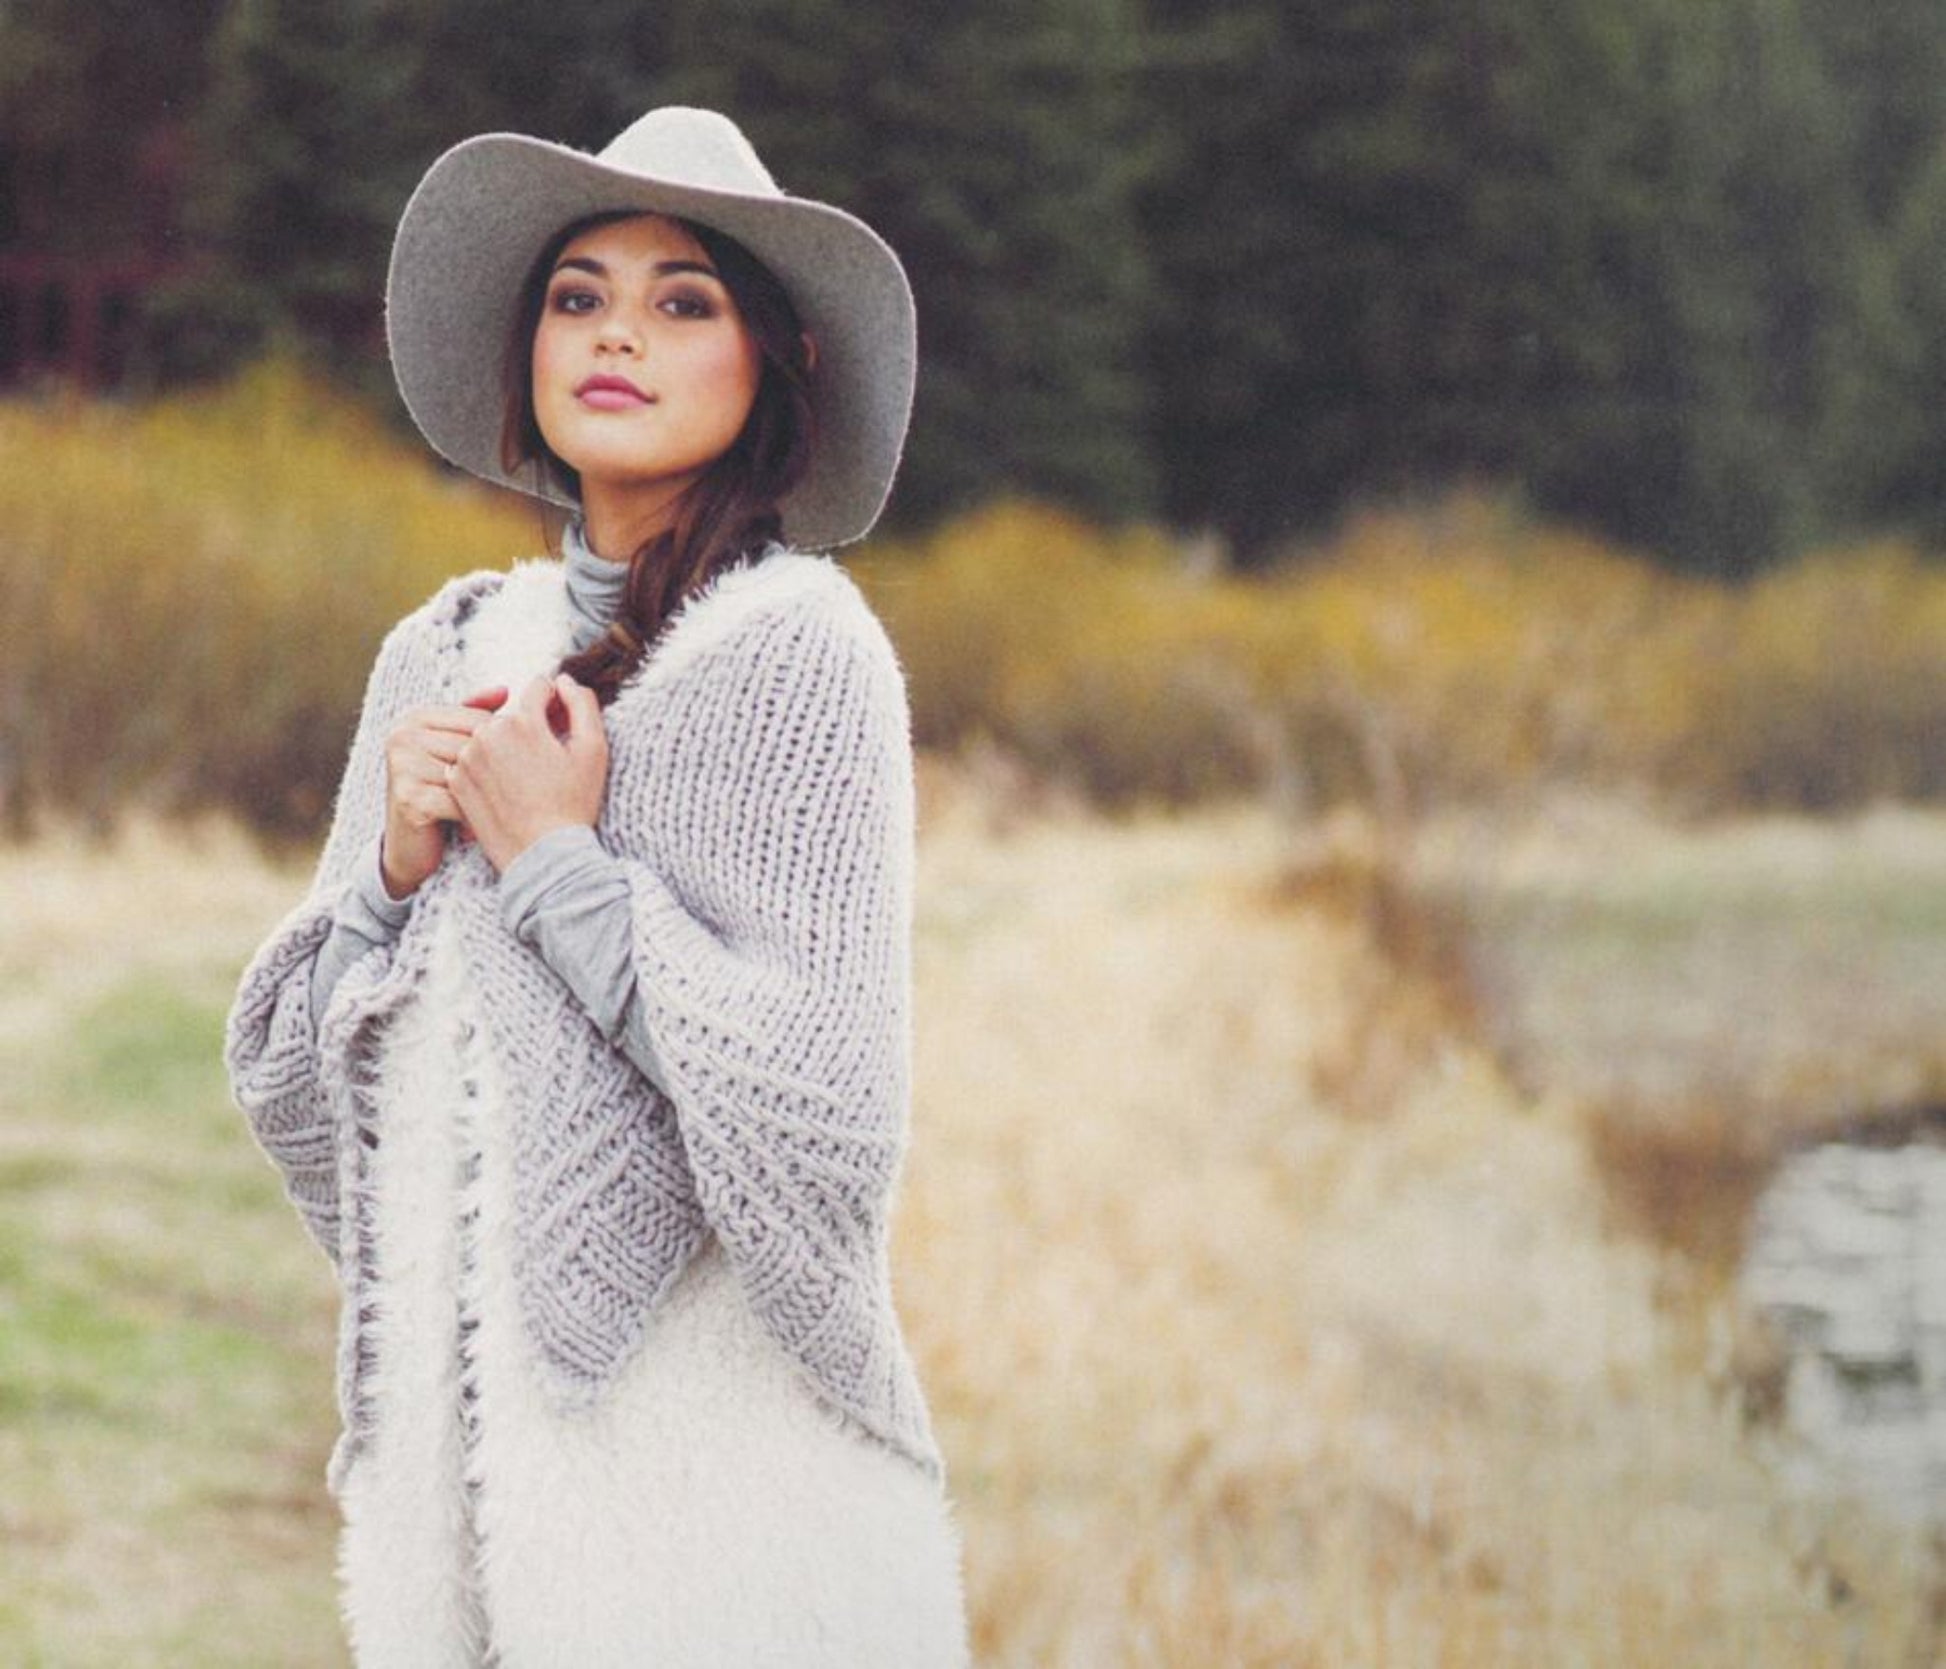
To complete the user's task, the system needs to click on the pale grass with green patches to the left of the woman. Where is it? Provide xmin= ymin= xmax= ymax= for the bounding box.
xmin=0 ymin=820 xmax=344 ymax=1669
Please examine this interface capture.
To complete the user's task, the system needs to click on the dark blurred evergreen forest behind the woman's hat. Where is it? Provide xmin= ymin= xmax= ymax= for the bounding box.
xmin=0 ymin=0 xmax=1946 ymax=578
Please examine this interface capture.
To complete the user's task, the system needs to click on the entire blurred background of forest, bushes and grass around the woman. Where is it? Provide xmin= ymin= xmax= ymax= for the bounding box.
xmin=0 ymin=0 xmax=1946 ymax=1669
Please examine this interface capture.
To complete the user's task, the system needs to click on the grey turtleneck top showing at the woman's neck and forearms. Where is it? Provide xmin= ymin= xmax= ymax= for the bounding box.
xmin=311 ymin=521 xmax=660 ymax=1082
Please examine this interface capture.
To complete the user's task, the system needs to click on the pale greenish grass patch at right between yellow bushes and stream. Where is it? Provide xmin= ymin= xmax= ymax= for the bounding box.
xmin=1424 ymin=807 xmax=1946 ymax=1130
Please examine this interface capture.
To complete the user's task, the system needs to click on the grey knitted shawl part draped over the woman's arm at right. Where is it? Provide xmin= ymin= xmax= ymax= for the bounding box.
xmin=611 ymin=593 xmax=928 ymax=1449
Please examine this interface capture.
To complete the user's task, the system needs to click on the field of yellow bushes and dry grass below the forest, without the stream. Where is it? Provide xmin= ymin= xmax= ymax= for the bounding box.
xmin=0 ymin=366 xmax=1946 ymax=1669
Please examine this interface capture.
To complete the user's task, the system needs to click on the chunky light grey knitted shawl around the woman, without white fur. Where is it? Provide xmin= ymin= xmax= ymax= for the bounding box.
xmin=226 ymin=549 xmax=944 ymax=1478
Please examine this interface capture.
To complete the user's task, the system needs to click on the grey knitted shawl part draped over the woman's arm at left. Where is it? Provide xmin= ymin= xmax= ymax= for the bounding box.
xmin=224 ymin=615 xmax=438 ymax=1262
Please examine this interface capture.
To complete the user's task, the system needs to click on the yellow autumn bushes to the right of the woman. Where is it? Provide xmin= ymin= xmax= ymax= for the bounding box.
xmin=866 ymin=496 xmax=1946 ymax=811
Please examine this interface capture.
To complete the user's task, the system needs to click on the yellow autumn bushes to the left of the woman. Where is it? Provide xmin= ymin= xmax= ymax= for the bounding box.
xmin=0 ymin=364 xmax=537 ymax=835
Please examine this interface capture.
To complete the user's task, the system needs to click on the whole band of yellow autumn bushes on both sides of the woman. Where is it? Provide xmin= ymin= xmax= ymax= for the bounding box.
xmin=0 ymin=364 xmax=1946 ymax=836
